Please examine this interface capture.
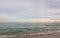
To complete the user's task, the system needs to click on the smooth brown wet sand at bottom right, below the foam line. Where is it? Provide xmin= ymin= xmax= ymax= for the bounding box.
xmin=20 ymin=32 xmax=60 ymax=38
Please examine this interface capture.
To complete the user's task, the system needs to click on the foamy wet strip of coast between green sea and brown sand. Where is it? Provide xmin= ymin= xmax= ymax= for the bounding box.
xmin=0 ymin=31 xmax=60 ymax=38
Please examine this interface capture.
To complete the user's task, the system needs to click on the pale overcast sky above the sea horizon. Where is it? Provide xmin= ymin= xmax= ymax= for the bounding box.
xmin=0 ymin=0 xmax=60 ymax=22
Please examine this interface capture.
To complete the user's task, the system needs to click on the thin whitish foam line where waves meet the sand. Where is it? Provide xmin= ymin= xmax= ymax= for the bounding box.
xmin=0 ymin=31 xmax=60 ymax=38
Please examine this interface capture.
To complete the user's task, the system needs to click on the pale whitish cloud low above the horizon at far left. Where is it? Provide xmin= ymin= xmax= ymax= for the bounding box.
xmin=0 ymin=13 xmax=17 ymax=22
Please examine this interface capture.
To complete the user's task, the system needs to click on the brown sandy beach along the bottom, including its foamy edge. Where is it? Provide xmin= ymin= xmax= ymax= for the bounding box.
xmin=0 ymin=31 xmax=60 ymax=38
